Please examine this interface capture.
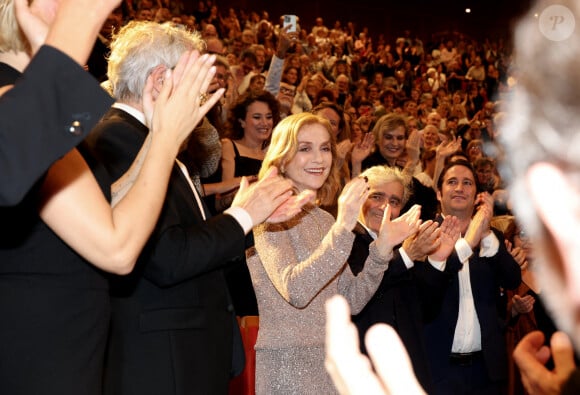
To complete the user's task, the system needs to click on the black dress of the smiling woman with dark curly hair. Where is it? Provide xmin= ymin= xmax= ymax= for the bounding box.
xmin=225 ymin=141 xmax=262 ymax=316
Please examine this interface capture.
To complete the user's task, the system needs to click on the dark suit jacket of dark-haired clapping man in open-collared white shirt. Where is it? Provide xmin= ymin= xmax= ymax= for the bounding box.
xmin=425 ymin=229 xmax=521 ymax=382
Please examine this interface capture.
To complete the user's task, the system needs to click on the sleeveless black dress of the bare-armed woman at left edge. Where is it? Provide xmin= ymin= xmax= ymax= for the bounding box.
xmin=0 ymin=63 xmax=110 ymax=395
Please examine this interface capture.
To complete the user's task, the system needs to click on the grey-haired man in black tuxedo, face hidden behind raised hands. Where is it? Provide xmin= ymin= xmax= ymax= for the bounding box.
xmin=89 ymin=22 xmax=304 ymax=394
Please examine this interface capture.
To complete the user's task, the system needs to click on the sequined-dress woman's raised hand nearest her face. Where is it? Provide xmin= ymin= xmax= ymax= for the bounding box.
xmin=336 ymin=177 xmax=369 ymax=230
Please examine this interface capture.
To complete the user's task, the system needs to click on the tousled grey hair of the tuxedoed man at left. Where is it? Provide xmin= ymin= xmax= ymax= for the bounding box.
xmin=107 ymin=21 xmax=205 ymax=100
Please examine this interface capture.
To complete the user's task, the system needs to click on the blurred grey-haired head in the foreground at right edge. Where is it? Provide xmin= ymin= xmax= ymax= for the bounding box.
xmin=501 ymin=0 xmax=580 ymax=350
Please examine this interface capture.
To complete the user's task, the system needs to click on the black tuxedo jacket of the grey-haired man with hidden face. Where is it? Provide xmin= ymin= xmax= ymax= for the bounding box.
xmin=87 ymin=108 xmax=245 ymax=395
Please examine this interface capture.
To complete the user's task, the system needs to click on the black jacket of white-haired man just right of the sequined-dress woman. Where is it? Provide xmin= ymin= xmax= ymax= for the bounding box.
xmin=348 ymin=223 xmax=458 ymax=392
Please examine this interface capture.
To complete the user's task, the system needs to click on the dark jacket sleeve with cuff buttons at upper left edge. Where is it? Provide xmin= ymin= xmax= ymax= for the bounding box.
xmin=0 ymin=46 xmax=112 ymax=206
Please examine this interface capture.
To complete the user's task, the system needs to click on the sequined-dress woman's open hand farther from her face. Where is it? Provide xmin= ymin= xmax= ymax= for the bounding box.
xmin=376 ymin=204 xmax=421 ymax=257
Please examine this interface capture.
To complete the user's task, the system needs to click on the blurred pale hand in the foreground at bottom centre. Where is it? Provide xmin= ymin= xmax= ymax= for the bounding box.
xmin=325 ymin=295 xmax=425 ymax=395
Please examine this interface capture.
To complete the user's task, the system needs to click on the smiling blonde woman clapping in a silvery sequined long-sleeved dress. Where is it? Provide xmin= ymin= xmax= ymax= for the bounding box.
xmin=247 ymin=113 xmax=420 ymax=395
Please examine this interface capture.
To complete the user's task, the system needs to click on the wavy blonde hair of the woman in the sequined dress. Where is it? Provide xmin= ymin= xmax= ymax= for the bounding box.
xmin=258 ymin=113 xmax=340 ymax=206
